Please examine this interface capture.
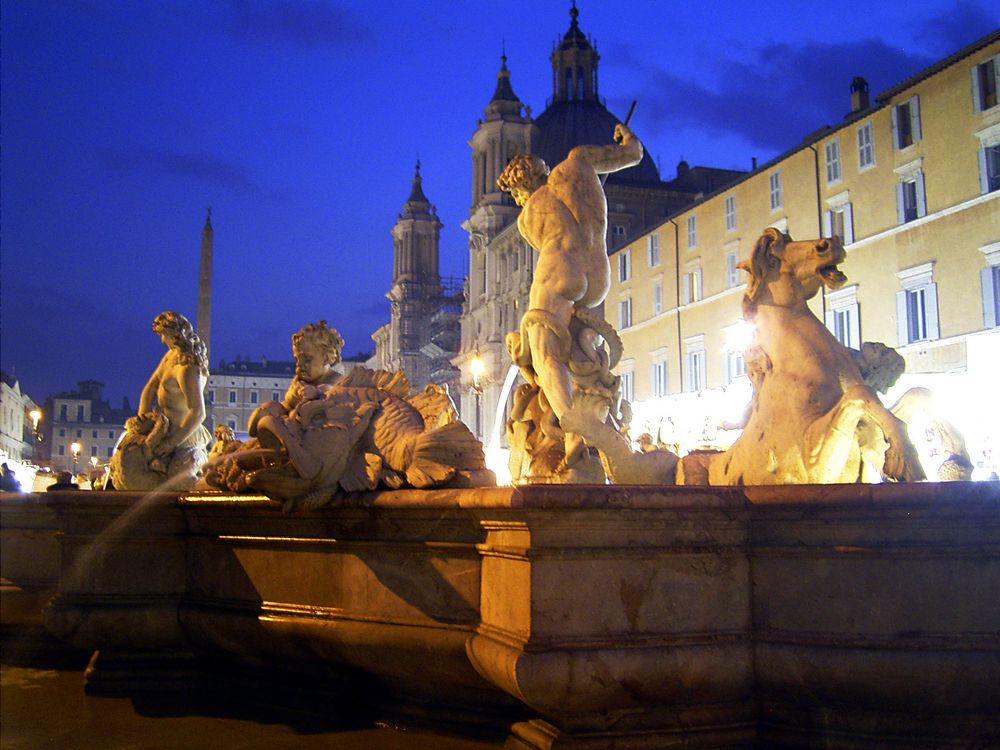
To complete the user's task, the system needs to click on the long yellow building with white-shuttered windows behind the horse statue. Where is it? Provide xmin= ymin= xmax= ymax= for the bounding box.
xmin=605 ymin=31 xmax=1000 ymax=476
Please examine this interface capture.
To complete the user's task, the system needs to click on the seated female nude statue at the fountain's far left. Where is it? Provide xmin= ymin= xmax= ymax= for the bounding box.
xmin=109 ymin=310 xmax=211 ymax=491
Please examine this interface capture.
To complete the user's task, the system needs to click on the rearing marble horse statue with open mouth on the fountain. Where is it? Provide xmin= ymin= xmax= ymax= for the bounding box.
xmin=704 ymin=228 xmax=924 ymax=485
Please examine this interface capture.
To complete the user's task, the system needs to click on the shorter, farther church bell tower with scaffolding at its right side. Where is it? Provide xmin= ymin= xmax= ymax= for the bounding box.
xmin=371 ymin=163 xmax=463 ymax=400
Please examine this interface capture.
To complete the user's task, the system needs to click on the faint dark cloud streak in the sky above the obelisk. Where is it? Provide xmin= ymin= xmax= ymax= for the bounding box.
xmin=99 ymin=148 xmax=260 ymax=195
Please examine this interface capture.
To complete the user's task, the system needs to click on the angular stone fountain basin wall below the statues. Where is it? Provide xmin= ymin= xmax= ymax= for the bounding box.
xmin=3 ymin=483 xmax=1000 ymax=748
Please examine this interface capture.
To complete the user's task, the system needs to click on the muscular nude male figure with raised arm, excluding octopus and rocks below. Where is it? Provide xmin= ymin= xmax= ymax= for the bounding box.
xmin=497 ymin=123 xmax=642 ymax=472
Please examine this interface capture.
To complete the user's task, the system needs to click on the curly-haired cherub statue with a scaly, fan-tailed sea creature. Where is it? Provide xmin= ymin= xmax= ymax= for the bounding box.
xmin=199 ymin=321 xmax=495 ymax=509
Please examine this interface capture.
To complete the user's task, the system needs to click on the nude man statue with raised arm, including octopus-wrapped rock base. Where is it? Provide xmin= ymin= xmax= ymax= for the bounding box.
xmin=497 ymin=124 xmax=643 ymax=483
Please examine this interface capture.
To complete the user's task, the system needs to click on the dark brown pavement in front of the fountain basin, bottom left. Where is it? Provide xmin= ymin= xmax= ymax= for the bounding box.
xmin=0 ymin=634 xmax=499 ymax=750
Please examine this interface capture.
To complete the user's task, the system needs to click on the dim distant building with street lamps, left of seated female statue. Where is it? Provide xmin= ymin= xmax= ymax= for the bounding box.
xmin=43 ymin=380 xmax=135 ymax=471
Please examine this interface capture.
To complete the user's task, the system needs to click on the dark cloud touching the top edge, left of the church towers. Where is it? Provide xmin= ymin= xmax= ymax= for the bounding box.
xmin=225 ymin=0 xmax=374 ymax=49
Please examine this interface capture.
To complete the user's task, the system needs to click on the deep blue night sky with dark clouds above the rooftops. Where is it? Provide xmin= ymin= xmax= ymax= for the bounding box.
xmin=0 ymin=0 xmax=1000 ymax=406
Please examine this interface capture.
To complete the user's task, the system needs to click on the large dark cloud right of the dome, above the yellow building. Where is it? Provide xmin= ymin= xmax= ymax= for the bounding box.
xmin=612 ymin=39 xmax=932 ymax=156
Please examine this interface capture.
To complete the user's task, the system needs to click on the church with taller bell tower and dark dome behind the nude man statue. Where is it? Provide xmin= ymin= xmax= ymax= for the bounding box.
xmin=452 ymin=5 xmax=745 ymax=437
